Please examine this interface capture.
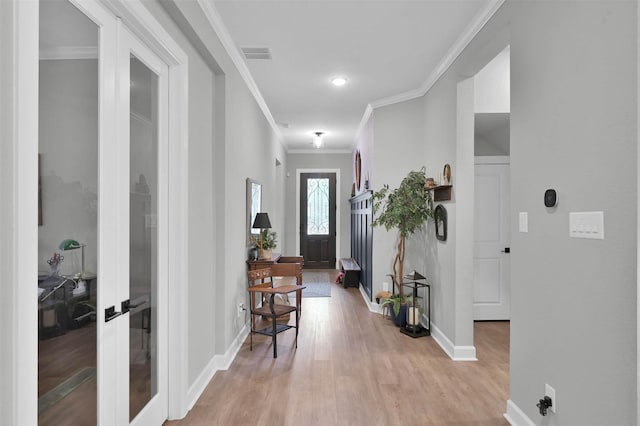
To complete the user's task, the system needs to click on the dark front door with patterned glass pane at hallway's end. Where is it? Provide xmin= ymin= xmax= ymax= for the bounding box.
xmin=300 ymin=173 xmax=336 ymax=269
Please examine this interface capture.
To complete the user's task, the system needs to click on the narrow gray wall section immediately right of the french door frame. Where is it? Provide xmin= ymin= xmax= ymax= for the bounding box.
xmin=145 ymin=2 xmax=219 ymax=384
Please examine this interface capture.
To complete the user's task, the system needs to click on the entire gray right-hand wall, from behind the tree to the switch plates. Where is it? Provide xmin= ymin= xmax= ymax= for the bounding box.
xmin=374 ymin=1 xmax=638 ymax=426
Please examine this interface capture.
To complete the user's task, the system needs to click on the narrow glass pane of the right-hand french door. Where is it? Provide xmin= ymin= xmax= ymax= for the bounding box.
xmin=129 ymin=55 xmax=158 ymax=420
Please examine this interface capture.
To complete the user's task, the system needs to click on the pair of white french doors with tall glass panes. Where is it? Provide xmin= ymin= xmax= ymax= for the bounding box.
xmin=38 ymin=0 xmax=170 ymax=425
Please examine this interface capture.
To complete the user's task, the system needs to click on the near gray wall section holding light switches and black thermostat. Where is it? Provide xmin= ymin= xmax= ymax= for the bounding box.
xmin=505 ymin=1 xmax=638 ymax=426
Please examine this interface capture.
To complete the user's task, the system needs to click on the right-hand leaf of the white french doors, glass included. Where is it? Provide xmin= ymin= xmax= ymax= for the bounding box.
xmin=117 ymin=25 xmax=169 ymax=424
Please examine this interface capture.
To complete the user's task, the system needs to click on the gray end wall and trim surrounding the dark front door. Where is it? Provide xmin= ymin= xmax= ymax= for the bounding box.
xmin=283 ymin=153 xmax=353 ymax=257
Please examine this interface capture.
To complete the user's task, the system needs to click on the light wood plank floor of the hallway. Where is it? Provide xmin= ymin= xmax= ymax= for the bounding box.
xmin=165 ymin=272 xmax=509 ymax=426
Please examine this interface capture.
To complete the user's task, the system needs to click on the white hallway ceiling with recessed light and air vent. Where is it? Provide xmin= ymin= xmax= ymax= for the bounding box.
xmin=214 ymin=0 xmax=496 ymax=152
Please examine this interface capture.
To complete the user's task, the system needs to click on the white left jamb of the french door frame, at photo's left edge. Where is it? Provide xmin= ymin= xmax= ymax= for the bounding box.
xmin=5 ymin=0 xmax=39 ymax=425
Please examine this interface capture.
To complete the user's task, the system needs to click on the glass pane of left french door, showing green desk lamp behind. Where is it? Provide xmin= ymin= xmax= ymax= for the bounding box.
xmin=37 ymin=0 xmax=100 ymax=425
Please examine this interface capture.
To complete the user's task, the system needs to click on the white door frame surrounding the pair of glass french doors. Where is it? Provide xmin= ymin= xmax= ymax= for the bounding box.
xmin=9 ymin=0 xmax=189 ymax=425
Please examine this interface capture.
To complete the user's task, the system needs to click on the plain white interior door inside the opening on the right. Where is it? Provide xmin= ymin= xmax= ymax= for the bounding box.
xmin=473 ymin=157 xmax=511 ymax=320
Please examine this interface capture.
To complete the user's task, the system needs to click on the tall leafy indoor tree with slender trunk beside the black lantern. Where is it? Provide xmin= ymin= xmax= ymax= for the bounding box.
xmin=373 ymin=167 xmax=433 ymax=322
